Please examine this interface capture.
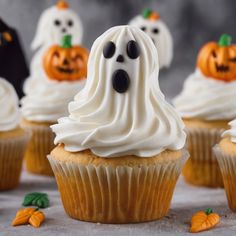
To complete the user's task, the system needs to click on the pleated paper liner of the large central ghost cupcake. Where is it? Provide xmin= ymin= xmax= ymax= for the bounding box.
xmin=48 ymin=151 xmax=188 ymax=223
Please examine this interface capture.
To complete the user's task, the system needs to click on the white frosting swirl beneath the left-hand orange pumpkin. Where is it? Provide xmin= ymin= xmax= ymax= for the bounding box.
xmin=21 ymin=76 xmax=86 ymax=122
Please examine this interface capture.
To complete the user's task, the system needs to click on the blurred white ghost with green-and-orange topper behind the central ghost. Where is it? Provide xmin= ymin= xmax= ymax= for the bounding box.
xmin=129 ymin=9 xmax=173 ymax=69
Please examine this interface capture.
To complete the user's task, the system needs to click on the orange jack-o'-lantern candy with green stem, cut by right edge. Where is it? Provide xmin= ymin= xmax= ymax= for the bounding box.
xmin=197 ymin=34 xmax=236 ymax=82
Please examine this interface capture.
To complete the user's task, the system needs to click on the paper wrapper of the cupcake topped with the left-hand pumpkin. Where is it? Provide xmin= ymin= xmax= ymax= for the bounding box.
xmin=22 ymin=124 xmax=55 ymax=176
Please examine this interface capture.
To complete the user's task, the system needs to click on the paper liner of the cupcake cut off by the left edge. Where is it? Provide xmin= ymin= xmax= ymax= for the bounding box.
xmin=0 ymin=132 xmax=30 ymax=190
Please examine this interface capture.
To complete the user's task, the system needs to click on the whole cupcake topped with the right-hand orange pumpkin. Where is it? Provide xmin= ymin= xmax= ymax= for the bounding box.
xmin=174 ymin=35 xmax=236 ymax=187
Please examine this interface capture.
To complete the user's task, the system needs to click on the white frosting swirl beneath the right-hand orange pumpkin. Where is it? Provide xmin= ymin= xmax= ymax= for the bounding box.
xmin=173 ymin=70 xmax=236 ymax=120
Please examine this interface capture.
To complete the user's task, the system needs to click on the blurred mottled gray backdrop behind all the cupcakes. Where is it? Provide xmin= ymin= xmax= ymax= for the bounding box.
xmin=0 ymin=0 xmax=236 ymax=97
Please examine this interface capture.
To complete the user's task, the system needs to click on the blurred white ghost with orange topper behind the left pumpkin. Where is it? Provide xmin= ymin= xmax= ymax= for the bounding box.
xmin=30 ymin=0 xmax=83 ymax=74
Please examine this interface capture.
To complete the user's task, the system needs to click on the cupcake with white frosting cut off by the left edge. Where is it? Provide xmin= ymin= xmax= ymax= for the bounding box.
xmin=0 ymin=78 xmax=30 ymax=190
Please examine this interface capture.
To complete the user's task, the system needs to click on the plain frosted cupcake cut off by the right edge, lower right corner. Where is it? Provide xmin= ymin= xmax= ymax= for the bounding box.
xmin=214 ymin=120 xmax=236 ymax=212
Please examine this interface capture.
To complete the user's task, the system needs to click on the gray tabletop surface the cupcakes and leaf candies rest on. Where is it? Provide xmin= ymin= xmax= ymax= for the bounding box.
xmin=0 ymin=173 xmax=236 ymax=236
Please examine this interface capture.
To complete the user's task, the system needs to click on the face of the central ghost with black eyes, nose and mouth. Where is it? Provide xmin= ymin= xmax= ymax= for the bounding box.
xmin=103 ymin=39 xmax=141 ymax=93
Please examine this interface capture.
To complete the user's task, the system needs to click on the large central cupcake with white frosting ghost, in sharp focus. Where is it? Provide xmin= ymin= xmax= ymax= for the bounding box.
xmin=48 ymin=26 xmax=188 ymax=223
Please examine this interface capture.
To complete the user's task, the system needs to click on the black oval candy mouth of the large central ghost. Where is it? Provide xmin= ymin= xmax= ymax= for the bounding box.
xmin=112 ymin=70 xmax=130 ymax=93
